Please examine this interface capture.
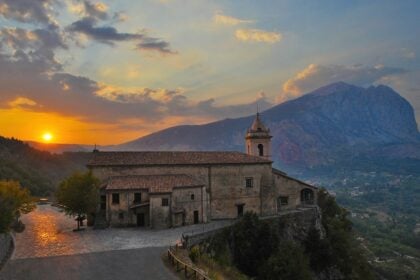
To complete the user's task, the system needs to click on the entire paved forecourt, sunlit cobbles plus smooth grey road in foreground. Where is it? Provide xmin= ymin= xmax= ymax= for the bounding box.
xmin=0 ymin=205 xmax=227 ymax=279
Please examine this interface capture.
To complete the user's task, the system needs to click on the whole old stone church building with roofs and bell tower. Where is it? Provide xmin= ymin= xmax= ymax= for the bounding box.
xmin=88 ymin=114 xmax=317 ymax=228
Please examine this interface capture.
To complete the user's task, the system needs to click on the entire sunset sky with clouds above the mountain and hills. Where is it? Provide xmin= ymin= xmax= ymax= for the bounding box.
xmin=0 ymin=0 xmax=420 ymax=144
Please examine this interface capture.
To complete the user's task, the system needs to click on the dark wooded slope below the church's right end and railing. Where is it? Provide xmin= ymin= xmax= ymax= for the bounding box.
xmin=190 ymin=189 xmax=377 ymax=280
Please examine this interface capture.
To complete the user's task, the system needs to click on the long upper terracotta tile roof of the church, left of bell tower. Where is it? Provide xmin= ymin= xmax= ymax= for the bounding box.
xmin=87 ymin=152 xmax=271 ymax=167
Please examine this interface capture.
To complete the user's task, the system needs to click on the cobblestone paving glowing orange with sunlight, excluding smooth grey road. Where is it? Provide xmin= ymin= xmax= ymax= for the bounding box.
xmin=12 ymin=205 xmax=228 ymax=259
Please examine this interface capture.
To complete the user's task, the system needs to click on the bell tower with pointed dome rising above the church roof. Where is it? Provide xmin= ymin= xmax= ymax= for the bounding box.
xmin=245 ymin=113 xmax=273 ymax=159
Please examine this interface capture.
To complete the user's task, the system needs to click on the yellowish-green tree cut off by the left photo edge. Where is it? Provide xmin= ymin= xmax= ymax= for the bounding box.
xmin=0 ymin=181 xmax=35 ymax=233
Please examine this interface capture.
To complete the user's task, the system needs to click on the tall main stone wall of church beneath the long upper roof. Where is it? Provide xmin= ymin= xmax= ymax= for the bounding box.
xmin=93 ymin=163 xmax=272 ymax=219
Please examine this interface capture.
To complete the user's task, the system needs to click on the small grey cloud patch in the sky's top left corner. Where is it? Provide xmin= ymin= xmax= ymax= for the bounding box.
xmin=0 ymin=0 xmax=59 ymax=24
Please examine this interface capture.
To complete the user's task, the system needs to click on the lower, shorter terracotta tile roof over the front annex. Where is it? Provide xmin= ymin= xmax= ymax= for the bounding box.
xmin=105 ymin=174 xmax=204 ymax=193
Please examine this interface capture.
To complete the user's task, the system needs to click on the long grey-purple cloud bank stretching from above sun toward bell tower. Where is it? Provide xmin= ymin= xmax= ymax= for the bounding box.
xmin=0 ymin=45 xmax=271 ymax=123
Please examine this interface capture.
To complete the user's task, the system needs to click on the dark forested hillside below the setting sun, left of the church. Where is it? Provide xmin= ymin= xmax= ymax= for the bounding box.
xmin=0 ymin=136 xmax=90 ymax=196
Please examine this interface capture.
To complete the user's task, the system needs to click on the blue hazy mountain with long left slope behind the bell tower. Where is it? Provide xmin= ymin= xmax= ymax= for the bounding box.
xmin=110 ymin=82 xmax=420 ymax=173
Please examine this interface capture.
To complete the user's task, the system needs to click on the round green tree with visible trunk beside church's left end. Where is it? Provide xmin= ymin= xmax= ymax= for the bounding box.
xmin=56 ymin=171 xmax=99 ymax=230
